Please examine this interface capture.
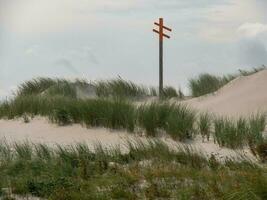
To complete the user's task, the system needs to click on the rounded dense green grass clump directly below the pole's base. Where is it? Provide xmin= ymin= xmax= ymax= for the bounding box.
xmin=138 ymin=103 xmax=195 ymax=140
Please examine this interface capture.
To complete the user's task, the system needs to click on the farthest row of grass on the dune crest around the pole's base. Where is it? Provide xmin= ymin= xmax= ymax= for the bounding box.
xmin=14 ymin=78 xmax=183 ymax=99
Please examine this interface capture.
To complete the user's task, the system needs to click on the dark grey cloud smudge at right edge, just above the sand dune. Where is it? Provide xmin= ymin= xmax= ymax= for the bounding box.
xmin=239 ymin=39 xmax=267 ymax=67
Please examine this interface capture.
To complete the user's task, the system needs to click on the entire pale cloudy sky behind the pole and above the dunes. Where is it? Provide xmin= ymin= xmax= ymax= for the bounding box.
xmin=0 ymin=0 xmax=267 ymax=98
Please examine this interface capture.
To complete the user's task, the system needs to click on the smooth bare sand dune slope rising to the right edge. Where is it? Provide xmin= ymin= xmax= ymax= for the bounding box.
xmin=185 ymin=70 xmax=267 ymax=116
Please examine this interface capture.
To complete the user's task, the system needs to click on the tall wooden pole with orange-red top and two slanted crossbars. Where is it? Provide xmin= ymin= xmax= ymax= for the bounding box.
xmin=153 ymin=18 xmax=172 ymax=97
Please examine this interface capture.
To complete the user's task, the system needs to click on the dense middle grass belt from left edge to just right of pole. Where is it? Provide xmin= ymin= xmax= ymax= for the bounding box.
xmin=0 ymin=95 xmax=195 ymax=140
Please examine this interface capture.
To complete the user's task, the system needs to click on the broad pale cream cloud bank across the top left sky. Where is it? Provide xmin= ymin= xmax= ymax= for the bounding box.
xmin=0 ymin=0 xmax=230 ymax=34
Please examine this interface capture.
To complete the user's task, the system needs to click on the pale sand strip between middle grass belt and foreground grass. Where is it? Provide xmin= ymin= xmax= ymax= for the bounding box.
xmin=0 ymin=117 xmax=252 ymax=158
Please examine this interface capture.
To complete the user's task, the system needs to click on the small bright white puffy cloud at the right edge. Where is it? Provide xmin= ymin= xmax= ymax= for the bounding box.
xmin=237 ymin=23 xmax=267 ymax=38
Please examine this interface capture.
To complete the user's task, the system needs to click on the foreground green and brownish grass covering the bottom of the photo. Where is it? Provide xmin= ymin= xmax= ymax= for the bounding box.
xmin=0 ymin=140 xmax=267 ymax=200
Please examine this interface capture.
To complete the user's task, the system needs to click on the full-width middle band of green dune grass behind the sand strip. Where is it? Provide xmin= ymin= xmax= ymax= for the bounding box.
xmin=0 ymin=90 xmax=266 ymax=149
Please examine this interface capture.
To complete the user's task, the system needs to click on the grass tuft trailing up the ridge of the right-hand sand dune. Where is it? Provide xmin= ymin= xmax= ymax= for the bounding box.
xmin=189 ymin=66 xmax=266 ymax=97
